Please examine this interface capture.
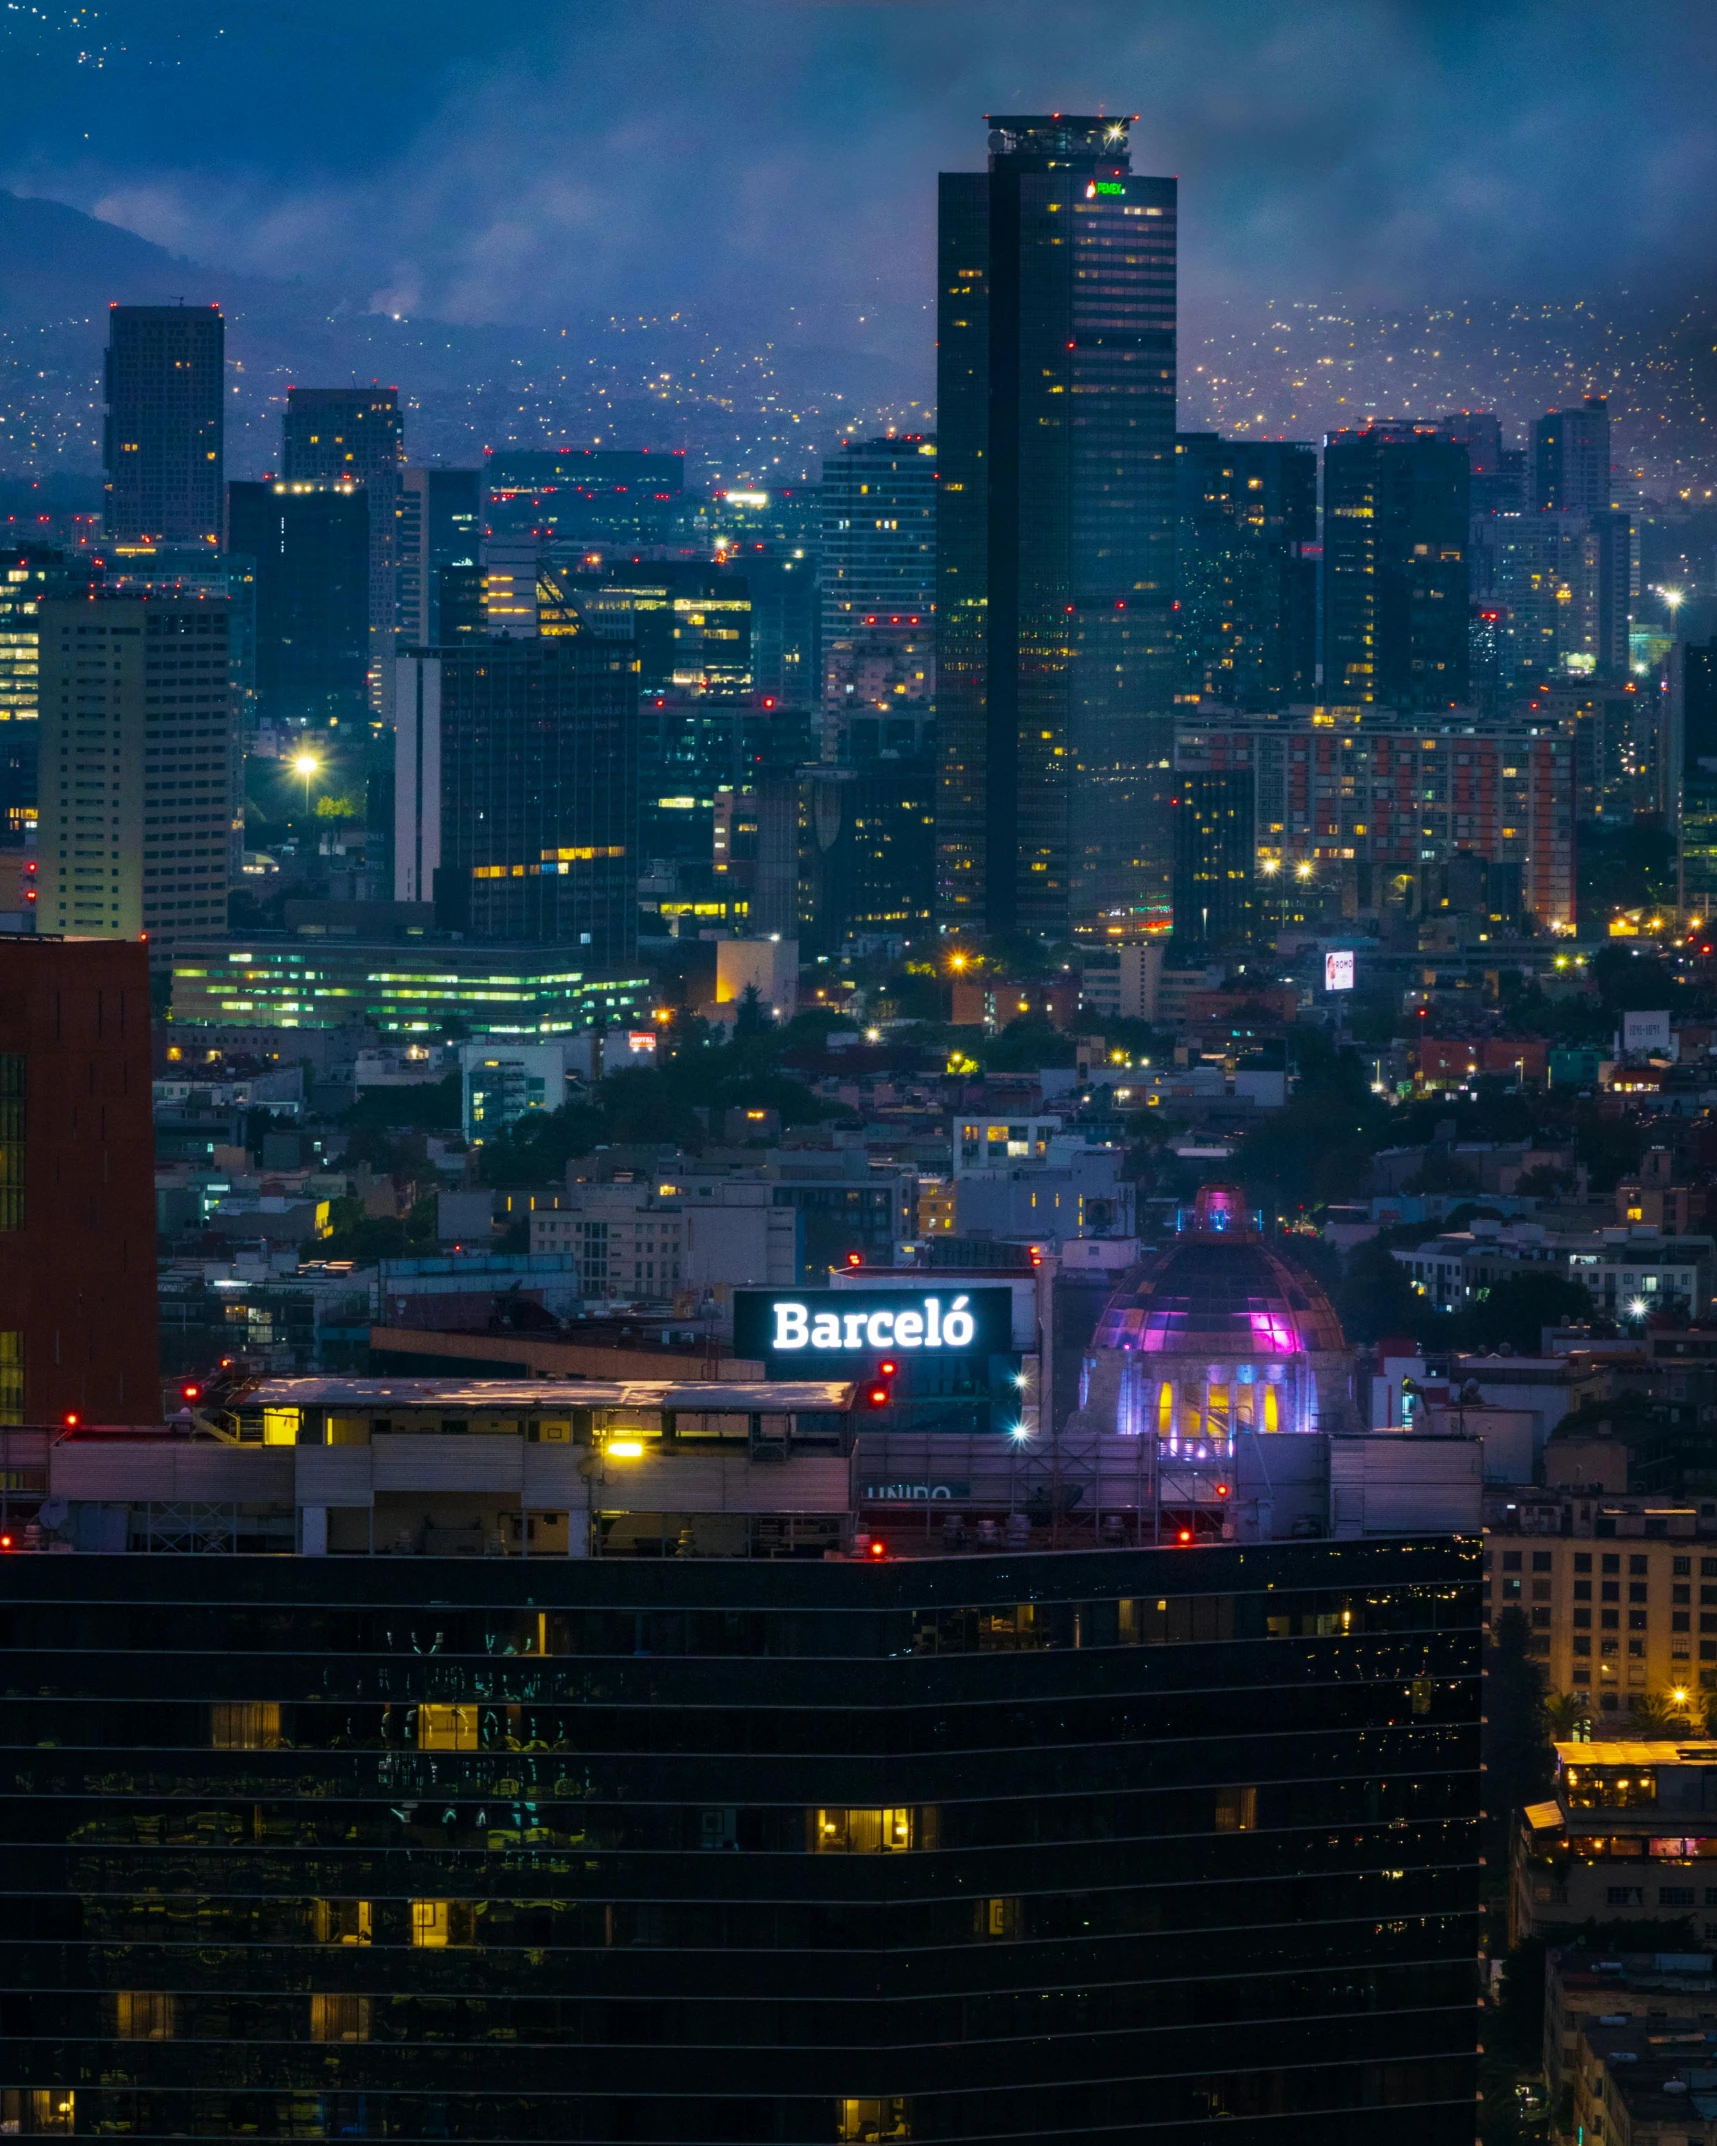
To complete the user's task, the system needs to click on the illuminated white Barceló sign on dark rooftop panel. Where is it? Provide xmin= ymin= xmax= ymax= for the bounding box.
xmin=734 ymin=1290 xmax=1013 ymax=1363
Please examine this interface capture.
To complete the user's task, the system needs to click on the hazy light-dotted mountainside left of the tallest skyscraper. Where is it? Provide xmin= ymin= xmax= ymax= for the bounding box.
xmin=0 ymin=191 xmax=910 ymax=483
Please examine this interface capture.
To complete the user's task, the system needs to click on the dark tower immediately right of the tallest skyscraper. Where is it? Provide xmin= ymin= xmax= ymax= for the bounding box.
xmin=1174 ymin=431 xmax=1318 ymax=708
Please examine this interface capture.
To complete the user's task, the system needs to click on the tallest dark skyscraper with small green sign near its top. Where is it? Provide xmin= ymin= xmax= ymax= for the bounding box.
xmin=936 ymin=114 xmax=1176 ymax=940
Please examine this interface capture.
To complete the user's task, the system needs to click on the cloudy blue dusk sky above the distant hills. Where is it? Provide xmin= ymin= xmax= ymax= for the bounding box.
xmin=0 ymin=0 xmax=1717 ymax=369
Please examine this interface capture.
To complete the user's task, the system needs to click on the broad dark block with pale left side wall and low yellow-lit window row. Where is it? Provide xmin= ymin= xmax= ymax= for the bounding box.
xmin=393 ymin=624 xmax=637 ymax=968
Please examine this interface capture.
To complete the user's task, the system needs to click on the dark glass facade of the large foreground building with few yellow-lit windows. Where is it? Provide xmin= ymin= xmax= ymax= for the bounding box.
xmin=0 ymin=1539 xmax=1479 ymax=2146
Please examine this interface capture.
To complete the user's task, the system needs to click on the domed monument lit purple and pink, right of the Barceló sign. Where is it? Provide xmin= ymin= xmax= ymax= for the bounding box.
xmin=1073 ymin=1185 xmax=1356 ymax=1532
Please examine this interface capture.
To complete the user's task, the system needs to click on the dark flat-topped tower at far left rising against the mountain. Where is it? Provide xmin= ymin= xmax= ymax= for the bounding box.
xmin=101 ymin=305 xmax=225 ymax=549
